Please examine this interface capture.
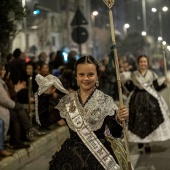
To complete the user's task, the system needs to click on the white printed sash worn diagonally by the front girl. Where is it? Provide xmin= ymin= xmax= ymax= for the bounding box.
xmin=66 ymin=97 xmax=120 ymax=170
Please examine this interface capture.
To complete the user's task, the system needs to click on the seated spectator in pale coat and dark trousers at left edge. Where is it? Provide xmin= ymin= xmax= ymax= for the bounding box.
xmin=0 ymin=62 xmax=45 ymax=149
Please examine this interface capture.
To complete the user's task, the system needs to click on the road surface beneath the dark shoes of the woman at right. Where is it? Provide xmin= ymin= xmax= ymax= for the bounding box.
xmin=130 ymin=140 xmax=170 ymax=170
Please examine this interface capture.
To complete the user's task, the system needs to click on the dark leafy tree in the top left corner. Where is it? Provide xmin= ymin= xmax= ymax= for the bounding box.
xmin=0 ymin=0 xmax=27 ymax=60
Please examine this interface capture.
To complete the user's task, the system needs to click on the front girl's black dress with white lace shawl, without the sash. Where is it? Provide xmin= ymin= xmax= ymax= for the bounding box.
xmin=38 ymin=89 xmax=122 ymax=170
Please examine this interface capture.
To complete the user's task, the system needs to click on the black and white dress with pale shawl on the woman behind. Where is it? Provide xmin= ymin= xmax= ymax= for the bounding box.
xmin=126 ymin=70 xmax=170 ymax=143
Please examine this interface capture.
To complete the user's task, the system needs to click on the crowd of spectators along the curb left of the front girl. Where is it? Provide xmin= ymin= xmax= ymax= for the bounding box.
xmin=0 ymin=48 xmax=83 ymax=157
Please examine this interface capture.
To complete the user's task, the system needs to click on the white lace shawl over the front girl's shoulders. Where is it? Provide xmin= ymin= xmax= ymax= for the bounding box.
xmin=56 ymin=89 xmax=118 ymax=131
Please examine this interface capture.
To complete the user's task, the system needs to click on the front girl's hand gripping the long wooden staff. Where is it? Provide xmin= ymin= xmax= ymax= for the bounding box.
xmin=117 ymin=106 xmax=129 ymax=122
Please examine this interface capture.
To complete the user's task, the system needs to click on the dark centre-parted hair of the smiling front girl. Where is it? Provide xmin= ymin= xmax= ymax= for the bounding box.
xmin=74 ymin=56 xmax=99 ymax=76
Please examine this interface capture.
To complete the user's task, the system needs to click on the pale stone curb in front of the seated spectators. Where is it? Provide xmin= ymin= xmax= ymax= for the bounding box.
xmin=0 ymin=126 xmax=69 ymax=170
